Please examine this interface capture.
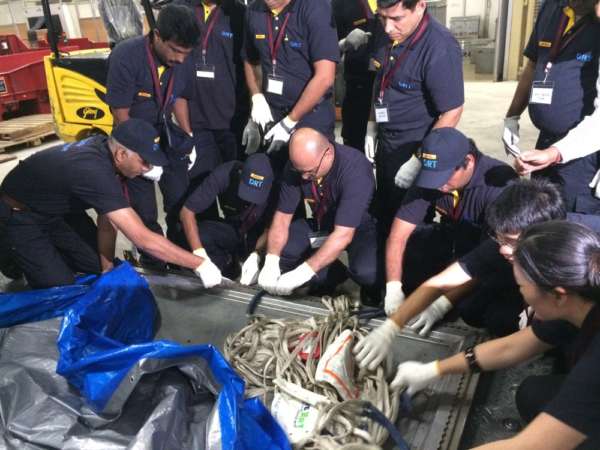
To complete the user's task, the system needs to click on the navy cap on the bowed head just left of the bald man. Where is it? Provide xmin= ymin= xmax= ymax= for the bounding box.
xmin=238 ymin=153 xmax=273 ymax=205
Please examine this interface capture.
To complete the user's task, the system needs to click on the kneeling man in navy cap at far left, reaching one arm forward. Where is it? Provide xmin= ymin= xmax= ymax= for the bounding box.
xmin=0 ymin=119 xmax=221 ymax=288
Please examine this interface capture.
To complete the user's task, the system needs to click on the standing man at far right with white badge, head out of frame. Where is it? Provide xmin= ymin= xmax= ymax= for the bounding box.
xmin=503 ymin=0 xmax=600 ymax=214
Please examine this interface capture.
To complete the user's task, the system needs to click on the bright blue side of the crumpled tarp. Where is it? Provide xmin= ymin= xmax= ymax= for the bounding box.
xmin=0 ymin=263 xmax=290 ymax=450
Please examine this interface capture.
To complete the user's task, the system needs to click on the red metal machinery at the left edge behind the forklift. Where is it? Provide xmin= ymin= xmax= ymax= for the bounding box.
xmin=0 ymin=34 xmax=108 ymax=120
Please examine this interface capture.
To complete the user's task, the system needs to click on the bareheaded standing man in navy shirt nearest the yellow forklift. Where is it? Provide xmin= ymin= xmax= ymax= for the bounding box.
xmin=106 ymin=5 xmax=200 ymax=266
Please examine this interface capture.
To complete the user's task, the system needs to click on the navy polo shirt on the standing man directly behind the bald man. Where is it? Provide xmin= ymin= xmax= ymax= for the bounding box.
xmin=243 ymin=0 xmax=340 ymax=114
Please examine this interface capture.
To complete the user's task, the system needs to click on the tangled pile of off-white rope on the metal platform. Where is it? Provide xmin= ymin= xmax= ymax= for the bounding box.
xmin=224 ymin=296 xmax=408 ymax=450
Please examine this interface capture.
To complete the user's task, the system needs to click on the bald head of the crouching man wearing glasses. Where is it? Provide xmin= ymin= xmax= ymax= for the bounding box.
xmin=289 ymin=128 xmax=329 ymax=178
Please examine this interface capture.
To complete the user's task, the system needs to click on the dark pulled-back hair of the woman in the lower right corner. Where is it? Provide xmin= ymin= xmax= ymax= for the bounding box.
xmin=515 ymin=220 xmax=600 ymax=302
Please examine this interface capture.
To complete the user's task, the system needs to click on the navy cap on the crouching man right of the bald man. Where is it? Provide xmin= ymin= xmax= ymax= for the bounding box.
xmin=414 ymin=128 xmax=471 ymax=189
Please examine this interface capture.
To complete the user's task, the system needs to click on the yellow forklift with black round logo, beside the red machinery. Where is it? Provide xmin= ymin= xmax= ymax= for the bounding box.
xmin=41 ymin=0 xmax=159 ymax=142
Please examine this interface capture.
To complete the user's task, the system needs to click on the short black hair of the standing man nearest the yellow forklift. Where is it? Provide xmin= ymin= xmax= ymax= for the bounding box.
xmin=156 ymin=3 xmax=200 ymax=48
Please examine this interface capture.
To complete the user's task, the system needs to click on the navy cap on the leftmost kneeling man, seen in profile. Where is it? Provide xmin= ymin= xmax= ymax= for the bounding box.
xmin=112 ymin=119 xmax=169 ymax=166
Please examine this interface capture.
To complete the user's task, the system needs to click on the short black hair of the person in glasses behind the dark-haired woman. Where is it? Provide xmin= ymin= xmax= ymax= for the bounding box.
xmin=485 ymin=178 xmax=567 ymax=234
